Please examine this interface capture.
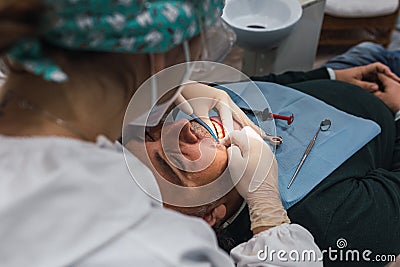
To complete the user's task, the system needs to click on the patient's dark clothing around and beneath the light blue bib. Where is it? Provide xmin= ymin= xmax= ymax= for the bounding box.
xmin=217 ymin=68 xmax=400 ymax=266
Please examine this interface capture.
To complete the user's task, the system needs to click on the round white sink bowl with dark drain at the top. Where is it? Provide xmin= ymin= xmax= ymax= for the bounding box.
xmin=222 ymin=0 xmax=303 ymax=50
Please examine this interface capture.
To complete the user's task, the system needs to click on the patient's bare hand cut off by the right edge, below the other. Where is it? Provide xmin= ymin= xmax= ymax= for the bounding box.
xmin=373 ymin=74 xmax=400 ymax=113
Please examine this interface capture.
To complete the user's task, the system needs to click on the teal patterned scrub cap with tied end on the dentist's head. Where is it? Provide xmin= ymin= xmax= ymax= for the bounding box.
xmin=8 ymin=0 xmax=224 ymax=82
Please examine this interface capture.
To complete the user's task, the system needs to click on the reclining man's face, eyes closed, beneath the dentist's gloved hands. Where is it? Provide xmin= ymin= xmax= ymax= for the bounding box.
xmin=127 ymin=120 xmax=228 ymax=187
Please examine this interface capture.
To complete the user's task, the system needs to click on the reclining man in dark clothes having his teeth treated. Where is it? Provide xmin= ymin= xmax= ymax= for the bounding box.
xmin=128 ymin=62 xmax=400 ymax=266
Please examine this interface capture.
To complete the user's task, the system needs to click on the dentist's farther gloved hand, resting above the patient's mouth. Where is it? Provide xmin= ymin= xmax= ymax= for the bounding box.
xmin=175 ymin=82 xmax=267 ymax=138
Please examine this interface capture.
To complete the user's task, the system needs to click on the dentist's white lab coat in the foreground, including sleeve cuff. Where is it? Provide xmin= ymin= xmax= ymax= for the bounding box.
xmin=0 ymin=137 xmax=318 ymax=267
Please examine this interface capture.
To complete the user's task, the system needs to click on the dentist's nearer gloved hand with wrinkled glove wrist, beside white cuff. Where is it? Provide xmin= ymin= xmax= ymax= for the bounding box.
xmin=221 ymin=127 xmax=290 ymax=234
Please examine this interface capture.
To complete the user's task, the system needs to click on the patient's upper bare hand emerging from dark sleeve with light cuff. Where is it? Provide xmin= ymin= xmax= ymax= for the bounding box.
xmin=335 ymin=62 xmax=400 ymax=92
